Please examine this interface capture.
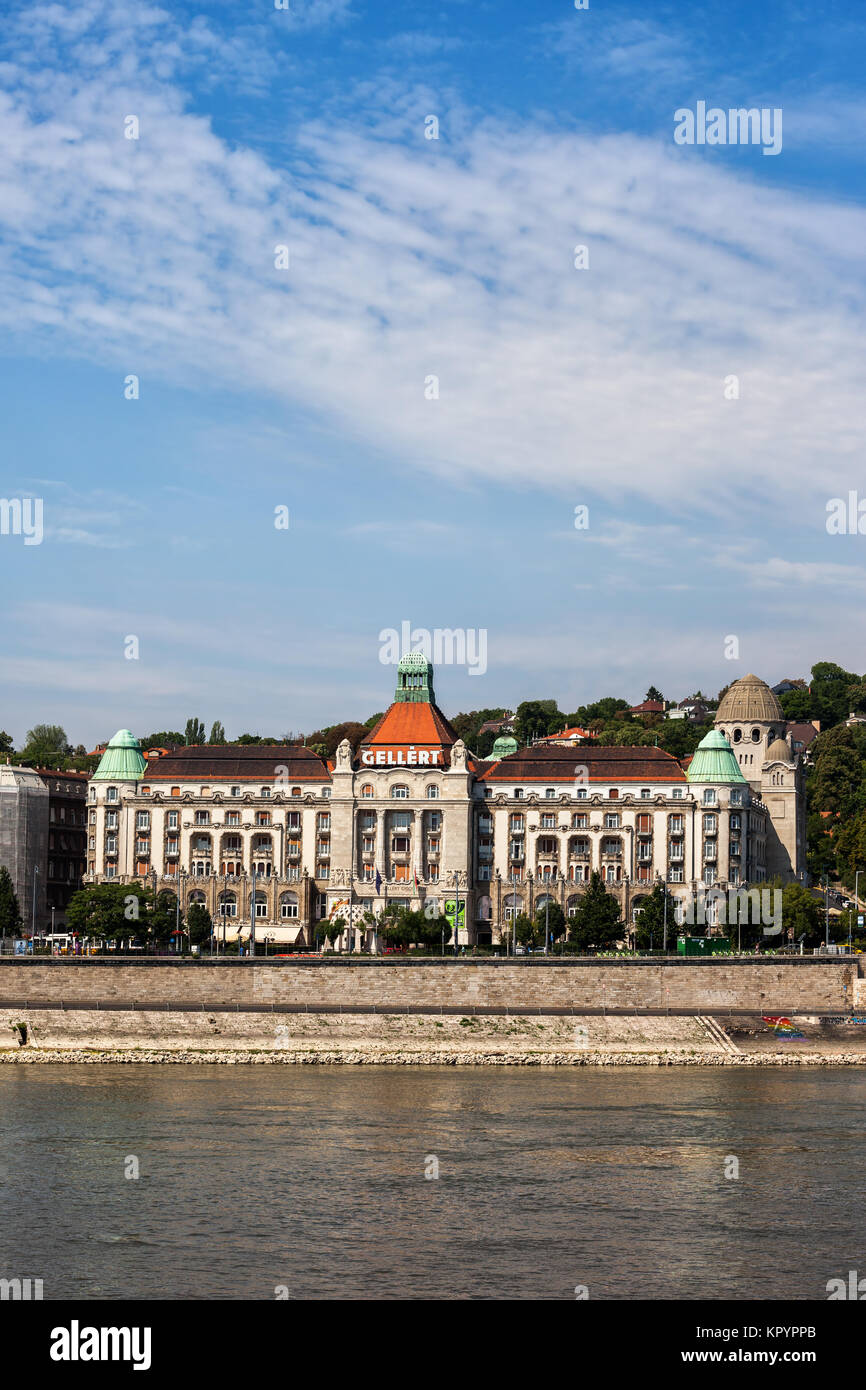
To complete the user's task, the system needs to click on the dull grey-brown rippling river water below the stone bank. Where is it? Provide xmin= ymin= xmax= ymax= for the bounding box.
xmin=0 ymin=1065 xmax=866 ymax=1300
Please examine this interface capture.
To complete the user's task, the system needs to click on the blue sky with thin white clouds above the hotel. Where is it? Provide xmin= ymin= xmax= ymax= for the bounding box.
xmin=0 ymin=0 xmax=866 ymax=746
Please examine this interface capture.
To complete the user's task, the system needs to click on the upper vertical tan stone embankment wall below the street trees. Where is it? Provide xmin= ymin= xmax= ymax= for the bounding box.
xmin=0 ymin=956 xmax=866 ymax=1013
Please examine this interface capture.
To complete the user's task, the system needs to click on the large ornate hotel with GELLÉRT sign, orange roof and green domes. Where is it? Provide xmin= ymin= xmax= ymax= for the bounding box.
xmin=88 ymin=652 xmax=802 ymax=944
